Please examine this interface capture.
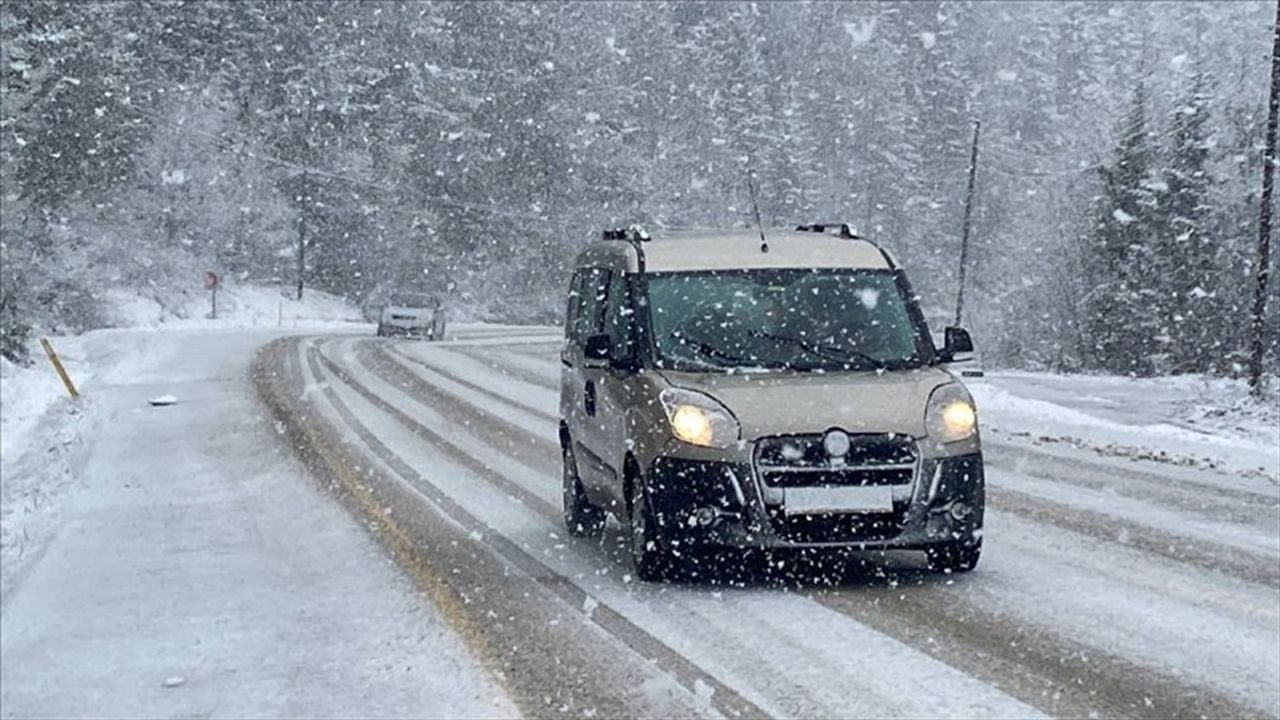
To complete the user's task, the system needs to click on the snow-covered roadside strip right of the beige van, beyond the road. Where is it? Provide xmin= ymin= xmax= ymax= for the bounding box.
xmin=965 ymin=372 xmax=1280 ymax=483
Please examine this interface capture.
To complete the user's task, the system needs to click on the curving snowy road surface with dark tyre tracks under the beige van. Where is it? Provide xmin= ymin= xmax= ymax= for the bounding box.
xmin=256 ymin=329 xmax=1280 ymax=717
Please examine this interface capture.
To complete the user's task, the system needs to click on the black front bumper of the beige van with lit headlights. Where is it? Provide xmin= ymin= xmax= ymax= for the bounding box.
xmin=645 ymin=452 xmax=986 ymax=550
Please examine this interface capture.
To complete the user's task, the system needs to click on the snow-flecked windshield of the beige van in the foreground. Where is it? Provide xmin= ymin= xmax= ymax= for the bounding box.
xmin=643 ymin=269 xmax=928 ymax=372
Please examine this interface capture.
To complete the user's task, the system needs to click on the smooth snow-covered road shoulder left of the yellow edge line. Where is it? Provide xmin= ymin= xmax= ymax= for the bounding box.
xmin=0 ymin=329 xmax=516 ymax=717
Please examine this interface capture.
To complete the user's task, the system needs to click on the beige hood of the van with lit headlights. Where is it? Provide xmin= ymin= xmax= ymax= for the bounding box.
xmin=663 ymin=368 xmax=955 ymax=441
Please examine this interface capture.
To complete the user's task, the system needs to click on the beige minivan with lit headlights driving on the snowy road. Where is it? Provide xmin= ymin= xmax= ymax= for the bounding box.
xmin=559 ymin=224 xmax=984 ymax=580
